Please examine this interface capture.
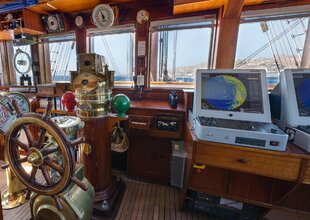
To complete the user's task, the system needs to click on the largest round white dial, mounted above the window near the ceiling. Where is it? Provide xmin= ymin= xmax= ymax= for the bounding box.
xmin=92 ymin=4 xmax=114 ymax=28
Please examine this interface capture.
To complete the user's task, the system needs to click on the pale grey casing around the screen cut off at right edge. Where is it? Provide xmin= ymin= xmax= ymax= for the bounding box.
xmin=281 ymin=69 xmax=310 ymax=126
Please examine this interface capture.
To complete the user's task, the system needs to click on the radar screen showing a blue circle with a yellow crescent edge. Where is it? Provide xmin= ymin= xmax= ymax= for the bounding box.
xmin=201 ymin=73 xmax=264 ymax=114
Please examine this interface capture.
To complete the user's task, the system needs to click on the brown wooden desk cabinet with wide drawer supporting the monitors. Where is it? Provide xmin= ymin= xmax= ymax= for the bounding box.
xmin=183 ymin=121 xmax=310 ymax=213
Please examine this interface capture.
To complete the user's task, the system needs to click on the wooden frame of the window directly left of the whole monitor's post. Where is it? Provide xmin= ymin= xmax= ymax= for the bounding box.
xmin=147 ymin=13 xmax=217 ymax=89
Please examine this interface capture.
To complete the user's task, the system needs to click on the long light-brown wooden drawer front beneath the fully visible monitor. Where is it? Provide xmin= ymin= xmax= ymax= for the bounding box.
xmin=195 ymin=142 xmax=301 ymax=181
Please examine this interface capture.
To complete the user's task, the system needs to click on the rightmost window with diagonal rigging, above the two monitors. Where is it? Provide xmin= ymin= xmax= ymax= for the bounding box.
xmin=235 ymin=8 xmax=310 ymax=89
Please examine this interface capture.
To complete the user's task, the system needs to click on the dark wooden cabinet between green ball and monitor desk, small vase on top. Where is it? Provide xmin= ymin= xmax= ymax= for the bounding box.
xmin=127 ymin=101 xmax=185 ymax=184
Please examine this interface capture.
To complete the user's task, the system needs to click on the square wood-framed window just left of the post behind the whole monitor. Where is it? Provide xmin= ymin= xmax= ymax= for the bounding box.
xmin=149 ymin=16 xmax=215 ymax=88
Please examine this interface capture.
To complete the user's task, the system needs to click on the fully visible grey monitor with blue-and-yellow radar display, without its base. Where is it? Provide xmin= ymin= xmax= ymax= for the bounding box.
xmin=193 ymin=69 xmax=271 ymax=123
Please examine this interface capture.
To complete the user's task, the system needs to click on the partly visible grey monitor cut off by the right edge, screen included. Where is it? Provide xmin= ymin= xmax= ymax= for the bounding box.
xmin=280 ymin=69 xmax=310 ymax=127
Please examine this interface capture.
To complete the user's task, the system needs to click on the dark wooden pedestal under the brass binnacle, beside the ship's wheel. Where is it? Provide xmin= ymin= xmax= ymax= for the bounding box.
xmin=79 ymin=115 xmax=127 ymax=219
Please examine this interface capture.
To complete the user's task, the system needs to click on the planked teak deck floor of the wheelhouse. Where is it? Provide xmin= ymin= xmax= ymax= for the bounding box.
xmin=0 ymin=162 xmax=220 ymax=220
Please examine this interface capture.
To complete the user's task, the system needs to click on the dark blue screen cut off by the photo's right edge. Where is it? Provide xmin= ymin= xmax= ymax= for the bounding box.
xmin=293 ymin=73 xmax=310 ymax=117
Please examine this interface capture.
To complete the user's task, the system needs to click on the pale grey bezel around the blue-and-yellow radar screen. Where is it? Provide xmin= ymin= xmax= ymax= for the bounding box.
xmin=194 ymin=69 xmax=271 ymax=123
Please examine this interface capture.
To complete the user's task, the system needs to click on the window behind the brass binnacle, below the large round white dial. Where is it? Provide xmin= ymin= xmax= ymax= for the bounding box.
xmin=88 ymin=25 xmax=135 ymax=87
